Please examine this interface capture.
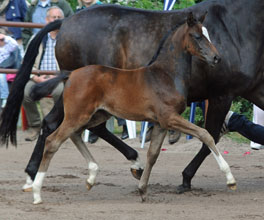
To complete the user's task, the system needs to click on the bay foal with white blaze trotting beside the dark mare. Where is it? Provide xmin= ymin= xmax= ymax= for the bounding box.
xmin=33 ymin=13 xmax=236 ymax=204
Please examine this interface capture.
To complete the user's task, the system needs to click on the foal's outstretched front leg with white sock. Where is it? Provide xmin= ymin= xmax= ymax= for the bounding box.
xmin=168 ymin=115 xmax=236 ymax=190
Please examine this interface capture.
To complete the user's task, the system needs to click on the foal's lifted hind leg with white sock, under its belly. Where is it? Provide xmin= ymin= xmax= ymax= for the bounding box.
xmin=71 ymin=133 xmax=99 ymax=190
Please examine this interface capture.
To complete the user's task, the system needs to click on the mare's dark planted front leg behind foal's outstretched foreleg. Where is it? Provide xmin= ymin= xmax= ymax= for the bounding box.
xmin=177 ymin=97 xmax=232 ymax=193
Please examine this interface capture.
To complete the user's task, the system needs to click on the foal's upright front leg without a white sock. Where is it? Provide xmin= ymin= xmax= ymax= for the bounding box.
xmin=138 ymin=124 xmax=167 ymax=202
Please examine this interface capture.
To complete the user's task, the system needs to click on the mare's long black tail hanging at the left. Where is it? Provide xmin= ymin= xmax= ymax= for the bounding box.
xmin=0 ymin=20 xmax=62 ymax=146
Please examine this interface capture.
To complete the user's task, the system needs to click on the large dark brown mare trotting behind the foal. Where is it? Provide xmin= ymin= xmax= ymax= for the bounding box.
xmin=0 ymin=0 xmax=264 ymax=191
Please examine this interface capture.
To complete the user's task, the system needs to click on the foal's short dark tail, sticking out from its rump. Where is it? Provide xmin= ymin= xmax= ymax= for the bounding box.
xmin=30 ymin=71 xmax=71 ymax=101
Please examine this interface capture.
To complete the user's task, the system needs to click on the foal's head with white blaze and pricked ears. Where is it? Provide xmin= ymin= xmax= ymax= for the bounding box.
xmin=183 ymin=12 xmax=221 ymax=65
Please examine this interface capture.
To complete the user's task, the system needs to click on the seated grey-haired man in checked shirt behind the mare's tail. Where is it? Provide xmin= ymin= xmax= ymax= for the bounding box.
xmin=23 ymin=6 xmax=64 ymax=141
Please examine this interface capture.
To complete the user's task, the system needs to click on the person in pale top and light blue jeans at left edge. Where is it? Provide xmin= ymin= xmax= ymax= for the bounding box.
xmin=0 ymin=28 xmax=18 ymax=108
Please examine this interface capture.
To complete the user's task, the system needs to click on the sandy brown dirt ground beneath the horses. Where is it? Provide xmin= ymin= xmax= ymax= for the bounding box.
xmin=0 ymin=131 xmax=264 ymax=220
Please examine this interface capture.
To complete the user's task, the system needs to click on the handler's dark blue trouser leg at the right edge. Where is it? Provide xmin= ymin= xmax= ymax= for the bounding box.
xmin=227 ymin=112 xmax=264 ymax=145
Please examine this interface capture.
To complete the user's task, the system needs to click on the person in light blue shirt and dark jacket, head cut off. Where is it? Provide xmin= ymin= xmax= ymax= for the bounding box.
xmin=22 ymin=0 xmax=73 ymax=48
